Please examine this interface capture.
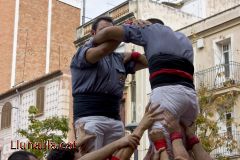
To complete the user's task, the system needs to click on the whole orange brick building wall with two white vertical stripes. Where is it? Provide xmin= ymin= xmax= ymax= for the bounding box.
xmin=0 ymin=0 xmax=80 ymax=93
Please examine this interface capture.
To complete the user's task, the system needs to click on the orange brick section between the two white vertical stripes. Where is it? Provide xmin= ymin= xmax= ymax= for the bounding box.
xmin=16 ymin=0 xmax=48 ymax=84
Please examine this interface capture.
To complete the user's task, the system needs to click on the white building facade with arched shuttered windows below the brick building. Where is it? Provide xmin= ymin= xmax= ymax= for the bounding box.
xmin=0 ymin=71 xmax=74 ymax=160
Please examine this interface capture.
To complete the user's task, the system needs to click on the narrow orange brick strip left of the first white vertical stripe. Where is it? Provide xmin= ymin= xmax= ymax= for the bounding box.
xmin=0 ymin=0 xmax=15 ymax=93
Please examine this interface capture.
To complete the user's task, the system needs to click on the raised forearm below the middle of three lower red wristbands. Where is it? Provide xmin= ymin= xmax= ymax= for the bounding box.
xmin=172 ymin=139 xmax=190 ymax=160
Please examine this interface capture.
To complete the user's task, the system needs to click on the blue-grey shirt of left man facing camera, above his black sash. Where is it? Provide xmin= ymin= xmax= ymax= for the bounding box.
xmin=70 ymin=40 xmax=135 ymax=98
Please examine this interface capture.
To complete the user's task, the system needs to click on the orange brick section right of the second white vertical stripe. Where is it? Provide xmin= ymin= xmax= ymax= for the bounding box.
xmin=49 ymin=0 xmax=80 ymax=71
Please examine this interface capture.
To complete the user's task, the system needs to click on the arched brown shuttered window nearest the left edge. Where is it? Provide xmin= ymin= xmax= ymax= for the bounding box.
xmin=1 ymin=102 xmax=12 ymax=129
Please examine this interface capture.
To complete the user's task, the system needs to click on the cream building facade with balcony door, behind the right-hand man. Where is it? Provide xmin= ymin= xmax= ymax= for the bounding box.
xmin=178 ymin=5 xmax=240 ymax=159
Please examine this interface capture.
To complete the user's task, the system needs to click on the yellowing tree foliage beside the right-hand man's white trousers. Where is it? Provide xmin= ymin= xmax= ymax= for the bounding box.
xmin=196 ymin=84 xmax=239 ymax=160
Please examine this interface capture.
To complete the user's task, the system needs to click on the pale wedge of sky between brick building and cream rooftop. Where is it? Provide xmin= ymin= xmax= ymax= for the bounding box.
xmin=85 ymin=0 xmax=126 ymax=22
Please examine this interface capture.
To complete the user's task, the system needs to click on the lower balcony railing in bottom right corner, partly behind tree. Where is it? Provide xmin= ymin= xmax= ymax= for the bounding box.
xmin=211 ymin=131 xmax=240 ymax=158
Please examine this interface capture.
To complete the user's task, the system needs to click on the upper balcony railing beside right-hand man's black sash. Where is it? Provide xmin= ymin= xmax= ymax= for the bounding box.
xmin=194 ymin=61 xmax=240 ymax=89
